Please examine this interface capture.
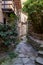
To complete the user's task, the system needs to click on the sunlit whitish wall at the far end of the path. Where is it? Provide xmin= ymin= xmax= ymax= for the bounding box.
xmin=20 ymin=12 xmax=27 ymax=35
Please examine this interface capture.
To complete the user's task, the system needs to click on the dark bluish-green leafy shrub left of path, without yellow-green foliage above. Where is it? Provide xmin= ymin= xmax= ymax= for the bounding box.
xmin=0 ymin=24 xmax=18 ymax=51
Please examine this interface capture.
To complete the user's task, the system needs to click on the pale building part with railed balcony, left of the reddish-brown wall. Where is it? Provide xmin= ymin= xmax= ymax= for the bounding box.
xmin=0 ymin=0 xmax=14 ymax=22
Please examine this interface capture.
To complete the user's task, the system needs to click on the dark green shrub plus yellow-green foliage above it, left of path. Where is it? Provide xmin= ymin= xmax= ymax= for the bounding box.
xmin=0 ymin=13 xmax=18 ymax=51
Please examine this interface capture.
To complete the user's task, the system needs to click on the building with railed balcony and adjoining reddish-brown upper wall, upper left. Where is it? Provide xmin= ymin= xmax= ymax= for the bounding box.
xmin=0 ymin=0 xmax=21 ymax=22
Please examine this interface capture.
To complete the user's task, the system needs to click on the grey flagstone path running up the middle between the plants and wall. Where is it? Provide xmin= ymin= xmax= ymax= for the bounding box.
xmin=0 ymin=36 xmax=37 ymax=65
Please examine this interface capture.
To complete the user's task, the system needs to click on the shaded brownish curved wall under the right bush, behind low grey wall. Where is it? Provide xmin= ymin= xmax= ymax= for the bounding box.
xmin=28 ymin=23 xmax=43 ymax=40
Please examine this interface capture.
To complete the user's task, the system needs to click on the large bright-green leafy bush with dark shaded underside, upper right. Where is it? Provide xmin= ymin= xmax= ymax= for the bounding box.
xmin=23 ymin=0 xmax=43 ymax=34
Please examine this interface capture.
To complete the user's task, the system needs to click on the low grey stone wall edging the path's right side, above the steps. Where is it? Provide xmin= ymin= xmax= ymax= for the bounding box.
xmin=27 ymin=36 xmax=43 ymax=50
